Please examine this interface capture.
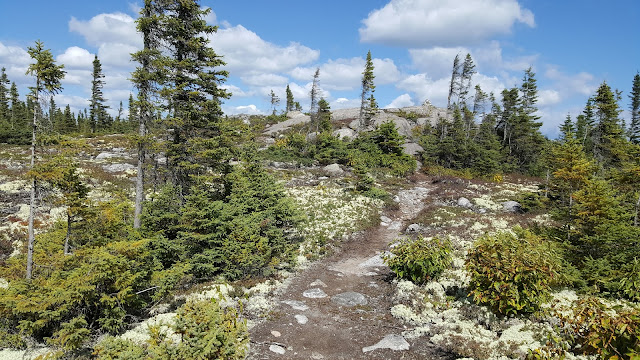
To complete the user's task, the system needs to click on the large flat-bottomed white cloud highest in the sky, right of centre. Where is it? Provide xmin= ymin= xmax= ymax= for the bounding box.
xmin=360 ymin=0 xmax=535 ymax=47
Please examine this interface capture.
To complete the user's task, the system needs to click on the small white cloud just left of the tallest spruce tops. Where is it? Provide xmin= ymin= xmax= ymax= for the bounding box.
xmin=69 ymin=13 xmax=142 ymax=48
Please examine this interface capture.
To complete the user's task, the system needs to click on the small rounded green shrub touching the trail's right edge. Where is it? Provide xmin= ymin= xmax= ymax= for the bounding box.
xmin=384 ymin=236 xmax=452 ymax=284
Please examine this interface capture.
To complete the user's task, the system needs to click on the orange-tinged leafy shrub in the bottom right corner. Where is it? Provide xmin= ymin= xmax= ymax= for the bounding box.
xmin=560 ymin=297 xmax=640 ymax=359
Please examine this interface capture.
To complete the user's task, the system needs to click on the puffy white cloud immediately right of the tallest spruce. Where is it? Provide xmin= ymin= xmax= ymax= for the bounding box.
xmin=211 ymin=25 xmax=320 ymax=76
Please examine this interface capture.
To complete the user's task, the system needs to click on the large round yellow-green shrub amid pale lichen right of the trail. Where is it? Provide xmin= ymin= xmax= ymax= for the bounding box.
xmin=466 ymin=227 xmax=562 ymax=315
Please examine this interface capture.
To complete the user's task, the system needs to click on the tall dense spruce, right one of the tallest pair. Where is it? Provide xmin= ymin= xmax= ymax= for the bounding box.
xmin=159 ymin=0 xmax=233 ymax=192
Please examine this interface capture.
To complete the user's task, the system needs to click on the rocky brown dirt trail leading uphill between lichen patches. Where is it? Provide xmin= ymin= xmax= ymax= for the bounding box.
xmin=250 ymin=183 xmax=448 ymax=359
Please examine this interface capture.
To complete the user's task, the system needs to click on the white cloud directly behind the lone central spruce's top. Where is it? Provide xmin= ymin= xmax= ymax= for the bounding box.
xmin=290 ymin=57 xmax=401 ymax=90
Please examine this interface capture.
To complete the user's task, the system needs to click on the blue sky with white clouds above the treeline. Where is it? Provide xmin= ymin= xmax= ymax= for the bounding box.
xmin=0 ymin=0 xmax=640 ymax=138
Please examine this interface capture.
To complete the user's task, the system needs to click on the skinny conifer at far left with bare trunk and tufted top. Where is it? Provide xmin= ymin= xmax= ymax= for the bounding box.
xmin=26 ymin=41 xmax=65 ymax=279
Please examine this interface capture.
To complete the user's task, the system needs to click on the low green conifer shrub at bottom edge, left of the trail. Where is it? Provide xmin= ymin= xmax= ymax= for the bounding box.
xmin=93 ymin=301 xmax=249 ymax=360
